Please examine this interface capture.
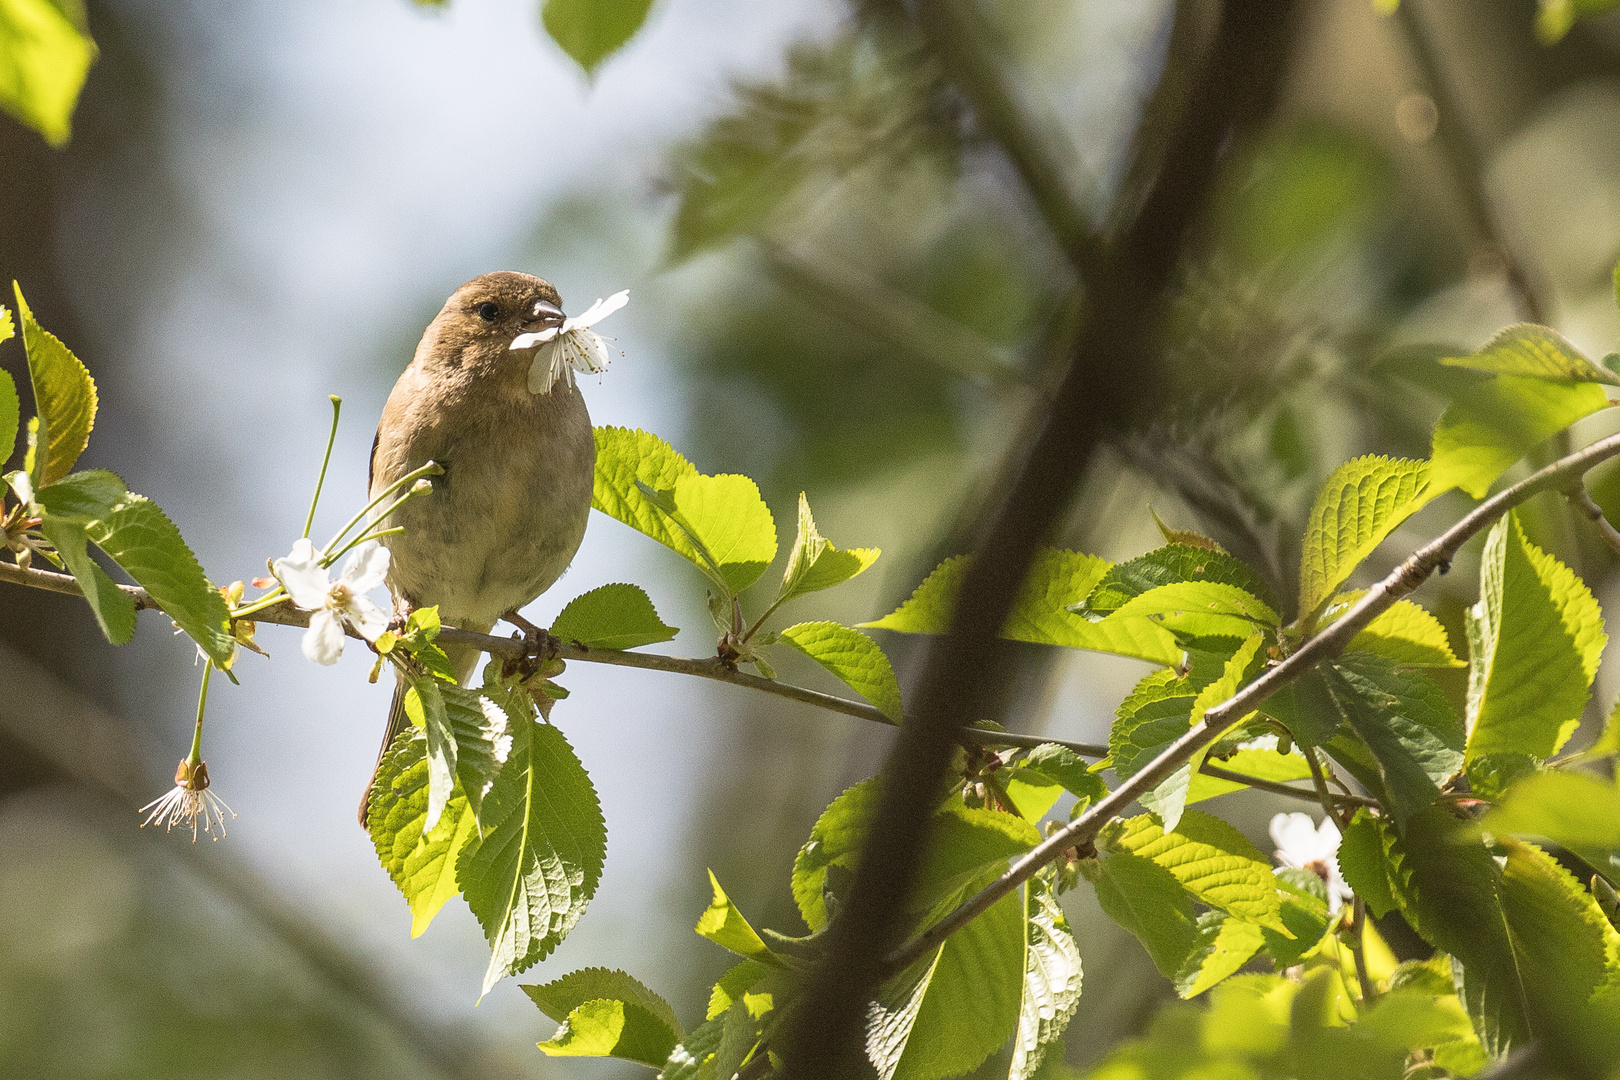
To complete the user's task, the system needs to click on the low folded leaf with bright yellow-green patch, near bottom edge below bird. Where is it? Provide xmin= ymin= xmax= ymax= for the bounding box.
xmin=523 ymin=968 xmax=685 ymax=1069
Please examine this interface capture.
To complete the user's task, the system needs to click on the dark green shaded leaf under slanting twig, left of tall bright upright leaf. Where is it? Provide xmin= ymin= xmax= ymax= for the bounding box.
xmin=1317 ymin=654 xmax=1463 ymax=823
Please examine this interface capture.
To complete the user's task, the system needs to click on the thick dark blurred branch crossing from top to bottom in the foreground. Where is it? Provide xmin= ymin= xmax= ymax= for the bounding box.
xmin=781 ymin=0 xmax=1293 ymax=1080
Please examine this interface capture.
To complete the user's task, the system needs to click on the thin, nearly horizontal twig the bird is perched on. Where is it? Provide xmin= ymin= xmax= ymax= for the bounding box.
xmin=0 ymin=562 xmax=1108 ymax=758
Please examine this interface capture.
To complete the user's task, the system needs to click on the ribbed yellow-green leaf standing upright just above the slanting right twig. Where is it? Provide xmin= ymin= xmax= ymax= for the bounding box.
xmin=1299 ymin=455 xmax=1432 ymax=614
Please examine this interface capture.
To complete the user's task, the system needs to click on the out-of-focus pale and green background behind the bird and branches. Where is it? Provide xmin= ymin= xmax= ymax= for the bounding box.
xmin=0 ymin=0 xmax=1620 ymax=1077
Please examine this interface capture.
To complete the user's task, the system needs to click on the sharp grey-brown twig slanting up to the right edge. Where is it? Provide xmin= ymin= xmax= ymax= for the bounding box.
xmin=883 ymin=436 xmax=1620 ymax=975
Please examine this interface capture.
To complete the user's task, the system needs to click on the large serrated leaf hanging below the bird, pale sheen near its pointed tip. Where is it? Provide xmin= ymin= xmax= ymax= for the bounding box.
xmin=455 ymin=721 xmax=608 ymax=994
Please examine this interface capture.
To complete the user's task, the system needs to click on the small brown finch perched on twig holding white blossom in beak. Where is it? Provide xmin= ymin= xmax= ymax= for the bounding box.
xmin=360 ymin=270 xmax=599 ymax=827
